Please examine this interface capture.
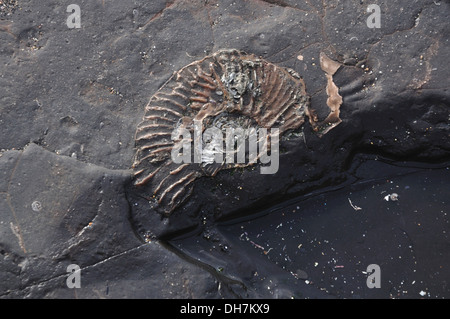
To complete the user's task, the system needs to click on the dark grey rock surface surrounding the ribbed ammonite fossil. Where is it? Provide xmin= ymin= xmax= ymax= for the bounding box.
xmin=0 ymin=0 xmax=450 ymax=298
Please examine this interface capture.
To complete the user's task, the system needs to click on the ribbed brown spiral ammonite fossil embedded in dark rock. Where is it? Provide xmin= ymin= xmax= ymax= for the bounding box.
xmin=133 ymin=50 xmax=309 ymax=214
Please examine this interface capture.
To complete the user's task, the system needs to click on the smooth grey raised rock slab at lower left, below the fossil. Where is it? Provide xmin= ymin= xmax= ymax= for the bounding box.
xmin=0 ymin=144 xmax=220 ymax=298
